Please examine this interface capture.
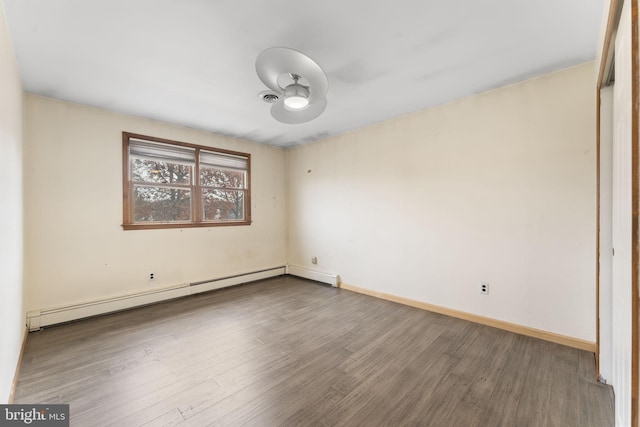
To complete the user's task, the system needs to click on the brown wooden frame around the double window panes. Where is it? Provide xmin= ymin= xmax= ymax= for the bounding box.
xmin=122 ymin=132 xmax=251 ymax=230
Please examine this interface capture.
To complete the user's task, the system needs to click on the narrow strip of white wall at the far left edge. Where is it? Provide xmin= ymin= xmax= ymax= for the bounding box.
xmin=0 ymin=0 xmax=25 ymax=403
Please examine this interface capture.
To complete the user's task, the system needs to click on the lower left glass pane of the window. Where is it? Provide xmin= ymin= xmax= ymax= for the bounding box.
xmin=133 ymin=185 xmax=191 ymax=222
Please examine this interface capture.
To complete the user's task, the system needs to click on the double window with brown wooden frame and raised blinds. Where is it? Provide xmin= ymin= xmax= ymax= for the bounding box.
xmin=122 ymin=132 xmax=251 ymax=230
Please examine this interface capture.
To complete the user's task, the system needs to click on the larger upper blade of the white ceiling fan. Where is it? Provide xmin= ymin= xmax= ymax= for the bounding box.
xmin=256 ymin=47 xmax=329 ymax=104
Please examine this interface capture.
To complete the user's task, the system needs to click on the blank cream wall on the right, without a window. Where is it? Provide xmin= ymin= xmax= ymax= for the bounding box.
xmin=288 ymin=63 xmax=595 ymax=341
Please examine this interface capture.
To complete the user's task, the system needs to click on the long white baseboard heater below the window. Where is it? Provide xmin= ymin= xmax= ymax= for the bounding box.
xmin=27 ymin=266 xmax=287 ymax=331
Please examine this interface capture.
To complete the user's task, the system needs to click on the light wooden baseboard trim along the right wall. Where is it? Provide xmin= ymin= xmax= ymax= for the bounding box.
xmin=339 ymin=283 xmax=596 ymax=353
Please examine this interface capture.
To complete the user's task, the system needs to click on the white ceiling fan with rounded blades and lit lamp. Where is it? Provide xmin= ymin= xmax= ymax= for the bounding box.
xmin=256 ymin=47 xmax=329 ymax=124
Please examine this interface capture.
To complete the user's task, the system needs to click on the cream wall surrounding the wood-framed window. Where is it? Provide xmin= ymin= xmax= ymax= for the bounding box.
xmin=25 ymin=95 xmax=286 ymax=310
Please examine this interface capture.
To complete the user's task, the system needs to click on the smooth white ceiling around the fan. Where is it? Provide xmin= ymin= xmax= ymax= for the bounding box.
xmin=3 ymin=0 xmax=604 ymax=146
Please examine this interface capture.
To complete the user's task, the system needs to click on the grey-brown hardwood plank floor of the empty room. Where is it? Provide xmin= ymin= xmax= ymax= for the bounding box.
xmin=15 ymin=276 xmax=614 ymax=427
